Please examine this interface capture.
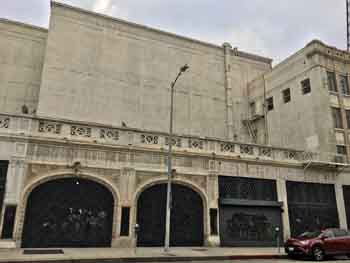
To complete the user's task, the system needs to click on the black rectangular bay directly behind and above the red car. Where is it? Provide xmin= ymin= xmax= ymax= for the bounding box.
xmin=287 ymin=181 xmax=339 ymax=236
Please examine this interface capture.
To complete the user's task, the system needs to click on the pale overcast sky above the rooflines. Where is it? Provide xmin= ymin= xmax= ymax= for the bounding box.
xmin=0 ymin=0 xmax=346 ymax=63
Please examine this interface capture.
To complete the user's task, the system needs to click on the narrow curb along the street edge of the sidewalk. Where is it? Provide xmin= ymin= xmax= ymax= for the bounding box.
xmin=0 ymin=254 xmax=287 ymax=263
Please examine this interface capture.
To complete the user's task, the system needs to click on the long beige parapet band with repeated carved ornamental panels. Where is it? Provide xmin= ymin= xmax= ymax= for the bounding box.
xmin=0 ymin=115 xmax=319 ymax=164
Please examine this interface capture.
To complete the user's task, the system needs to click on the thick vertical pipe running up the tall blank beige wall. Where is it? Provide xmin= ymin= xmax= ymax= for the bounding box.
xmin=222 ymin=42 xmax=233 ymax=140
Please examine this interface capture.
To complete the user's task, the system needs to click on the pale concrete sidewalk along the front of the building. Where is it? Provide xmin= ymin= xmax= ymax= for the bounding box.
xmin=0 ymin=247 xmax=286 ymax=263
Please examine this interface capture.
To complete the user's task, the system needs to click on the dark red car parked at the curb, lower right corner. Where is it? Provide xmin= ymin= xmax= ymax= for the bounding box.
xmin=284 ymin=228 xmax=350 ymax=261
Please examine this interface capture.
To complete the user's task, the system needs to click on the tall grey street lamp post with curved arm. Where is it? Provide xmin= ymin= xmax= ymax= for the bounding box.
xmin=164 ymin=64 xmax=189 ymax=252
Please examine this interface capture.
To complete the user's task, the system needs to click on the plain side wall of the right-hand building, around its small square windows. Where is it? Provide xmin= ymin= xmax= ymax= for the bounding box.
xmin=249 ymin=42 xmax=335 ymax=158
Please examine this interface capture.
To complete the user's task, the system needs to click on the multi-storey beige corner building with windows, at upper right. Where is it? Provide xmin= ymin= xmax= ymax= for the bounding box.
xmin=247 ymin=40 xmax=350 ymax=163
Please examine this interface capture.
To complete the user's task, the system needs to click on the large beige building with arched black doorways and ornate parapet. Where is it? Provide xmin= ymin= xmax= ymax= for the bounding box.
xmin=0 ymin=2 xmax=350 ymax=250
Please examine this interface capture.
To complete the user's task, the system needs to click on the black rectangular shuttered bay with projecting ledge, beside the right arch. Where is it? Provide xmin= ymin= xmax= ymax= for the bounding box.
xmin=219 ymin=176 xmax=283 ymax=247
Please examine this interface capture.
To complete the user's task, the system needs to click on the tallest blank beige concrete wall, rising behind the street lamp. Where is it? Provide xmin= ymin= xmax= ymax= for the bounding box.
xmin=38 ymin=4 xmax=269 ymax=138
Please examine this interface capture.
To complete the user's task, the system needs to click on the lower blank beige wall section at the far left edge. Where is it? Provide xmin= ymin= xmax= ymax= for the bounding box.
xmin=0 ymin=19 xmax=47 ymax=114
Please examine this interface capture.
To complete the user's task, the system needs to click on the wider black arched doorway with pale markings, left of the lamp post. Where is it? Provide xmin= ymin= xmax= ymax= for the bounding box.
xmin=22 ymin=178 xmax=114 ymax=248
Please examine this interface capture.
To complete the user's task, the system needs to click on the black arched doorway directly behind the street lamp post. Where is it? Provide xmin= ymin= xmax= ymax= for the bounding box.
xmin=137 ymin=183 xmax=203 ymax=246
